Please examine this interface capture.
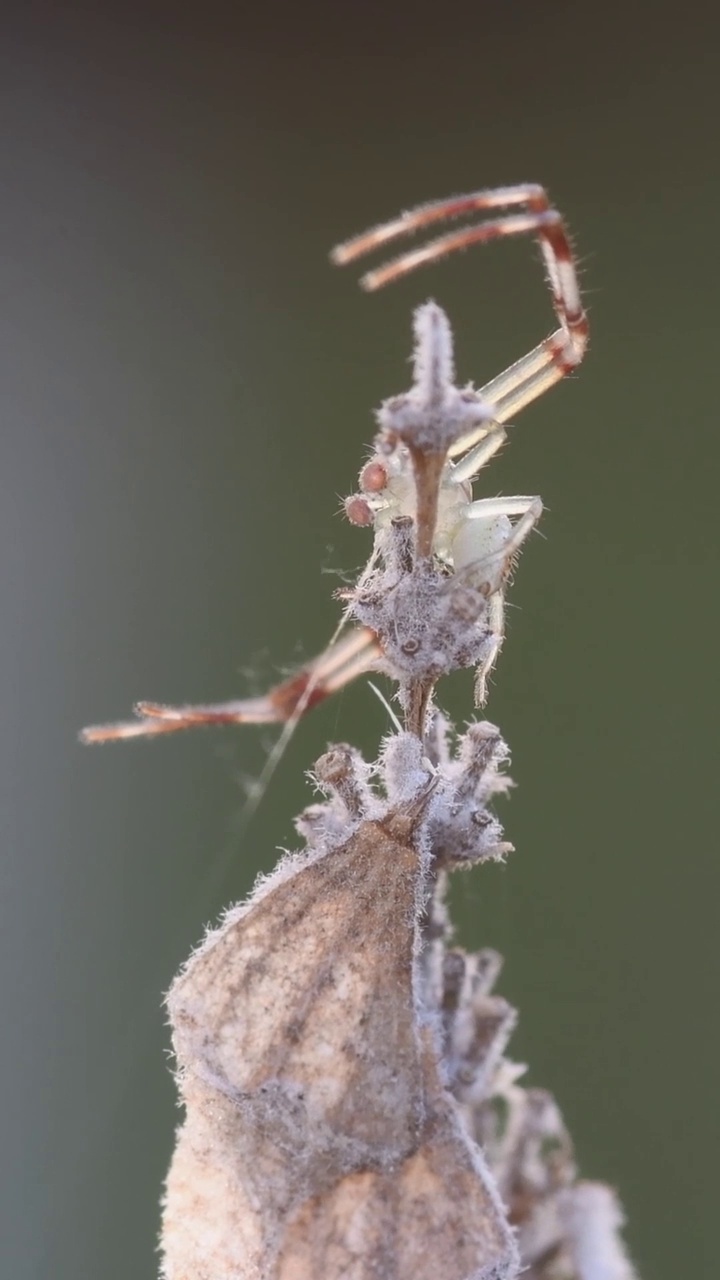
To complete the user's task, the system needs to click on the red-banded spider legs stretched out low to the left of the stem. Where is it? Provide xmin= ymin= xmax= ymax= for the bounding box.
xmin=79 ymin=627 xmax=380 ymax=742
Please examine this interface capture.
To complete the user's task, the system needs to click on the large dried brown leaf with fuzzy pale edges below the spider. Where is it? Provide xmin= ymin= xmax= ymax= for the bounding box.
xmin=163 ymin=808 xmax=516 ymax=1280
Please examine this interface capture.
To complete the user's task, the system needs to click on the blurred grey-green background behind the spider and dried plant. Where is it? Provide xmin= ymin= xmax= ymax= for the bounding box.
xmin=0 ymin=0 xmax=720 ymax=1280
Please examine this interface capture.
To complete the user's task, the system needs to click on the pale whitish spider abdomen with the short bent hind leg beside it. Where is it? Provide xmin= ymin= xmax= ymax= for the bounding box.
xmin=452 ymin=497 xmax=542 ymax=707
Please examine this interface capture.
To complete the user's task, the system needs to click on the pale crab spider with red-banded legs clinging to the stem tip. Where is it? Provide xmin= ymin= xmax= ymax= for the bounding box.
xmin=82 ymin=183 xmax=588 ymax=742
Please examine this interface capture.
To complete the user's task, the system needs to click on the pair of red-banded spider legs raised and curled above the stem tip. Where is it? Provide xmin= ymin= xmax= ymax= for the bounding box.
xmin=332 ymin=183 xmax=588 ymax=457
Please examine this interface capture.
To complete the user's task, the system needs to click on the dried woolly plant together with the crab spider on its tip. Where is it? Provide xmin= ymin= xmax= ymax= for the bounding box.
xmin=85 ymin=186 xmax=634 ymax=1280
